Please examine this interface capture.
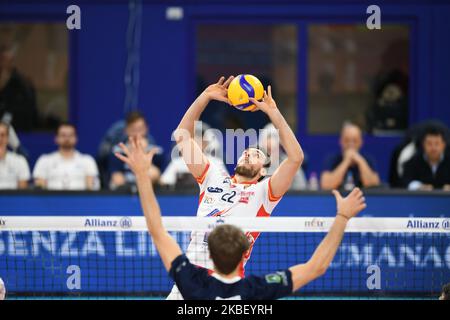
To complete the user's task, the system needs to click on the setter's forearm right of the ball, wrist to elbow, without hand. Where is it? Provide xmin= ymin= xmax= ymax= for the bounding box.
xmin=267 ymin=109 xmax=304 ymax=166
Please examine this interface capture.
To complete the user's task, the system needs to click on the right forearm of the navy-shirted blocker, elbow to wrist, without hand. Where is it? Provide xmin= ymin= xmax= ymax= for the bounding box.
xmin=308 ymin=215 xmax=347 ymax=276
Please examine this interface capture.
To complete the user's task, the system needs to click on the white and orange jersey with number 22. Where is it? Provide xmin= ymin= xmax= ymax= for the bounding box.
xmin=186 ymin=163 xmax=281 ymax=276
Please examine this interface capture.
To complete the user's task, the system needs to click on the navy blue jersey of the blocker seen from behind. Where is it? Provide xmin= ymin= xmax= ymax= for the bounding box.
xmin=169 ymin=254 xmax=292 ymax=300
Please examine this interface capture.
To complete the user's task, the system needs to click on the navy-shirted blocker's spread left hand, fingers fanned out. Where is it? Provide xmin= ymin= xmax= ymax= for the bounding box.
xmin=114 ymin=137 xmax=158 ymax=175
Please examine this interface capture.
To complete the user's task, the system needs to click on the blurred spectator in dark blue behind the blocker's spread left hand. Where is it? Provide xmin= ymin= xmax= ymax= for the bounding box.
xmin=108 ymin=111 xmax=162 ymax=190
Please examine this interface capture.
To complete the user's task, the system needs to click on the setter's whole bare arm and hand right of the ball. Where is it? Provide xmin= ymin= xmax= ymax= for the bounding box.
xmin=250 ymin=86 xmax=304 ymax=197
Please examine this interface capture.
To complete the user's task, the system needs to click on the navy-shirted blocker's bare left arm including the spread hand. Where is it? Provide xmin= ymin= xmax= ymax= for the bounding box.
xmin=115 ymin=137 xmax=182 ymax=271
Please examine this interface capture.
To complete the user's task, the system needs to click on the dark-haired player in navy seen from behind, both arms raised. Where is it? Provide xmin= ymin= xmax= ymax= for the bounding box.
xmin=116 ymin=137 xmax=366 ymax=300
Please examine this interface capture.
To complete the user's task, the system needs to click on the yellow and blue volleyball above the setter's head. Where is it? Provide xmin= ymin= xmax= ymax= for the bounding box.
xmin=228 ymin=74 xmax=264 ymax=111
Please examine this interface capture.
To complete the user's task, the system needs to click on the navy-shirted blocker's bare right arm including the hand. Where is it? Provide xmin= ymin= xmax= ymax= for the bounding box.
xmin=289 ymin=188 xmax=366 ymax=291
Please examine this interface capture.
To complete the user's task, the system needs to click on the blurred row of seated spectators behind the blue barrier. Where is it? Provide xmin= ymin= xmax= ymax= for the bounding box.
xmin=0 ymin=111 xmax=450 ymax=191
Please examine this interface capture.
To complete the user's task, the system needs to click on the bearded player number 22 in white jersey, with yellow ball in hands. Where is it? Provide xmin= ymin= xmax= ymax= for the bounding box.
xmin=167 ymin=74 xmax=303 ymax=300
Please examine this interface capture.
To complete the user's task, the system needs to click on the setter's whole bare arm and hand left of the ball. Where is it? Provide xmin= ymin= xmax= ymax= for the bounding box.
xmin=174 ymin=76 xmax=233 ymax=178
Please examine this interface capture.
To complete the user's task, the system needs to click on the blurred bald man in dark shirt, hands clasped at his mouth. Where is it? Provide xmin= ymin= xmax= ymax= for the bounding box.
xmin=320 ymin=123 xmax=380 ymax=190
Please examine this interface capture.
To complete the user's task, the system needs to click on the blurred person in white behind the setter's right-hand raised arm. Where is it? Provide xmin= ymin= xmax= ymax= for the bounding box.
xmin=258 ymin=123 xmax=308 ymax=190
